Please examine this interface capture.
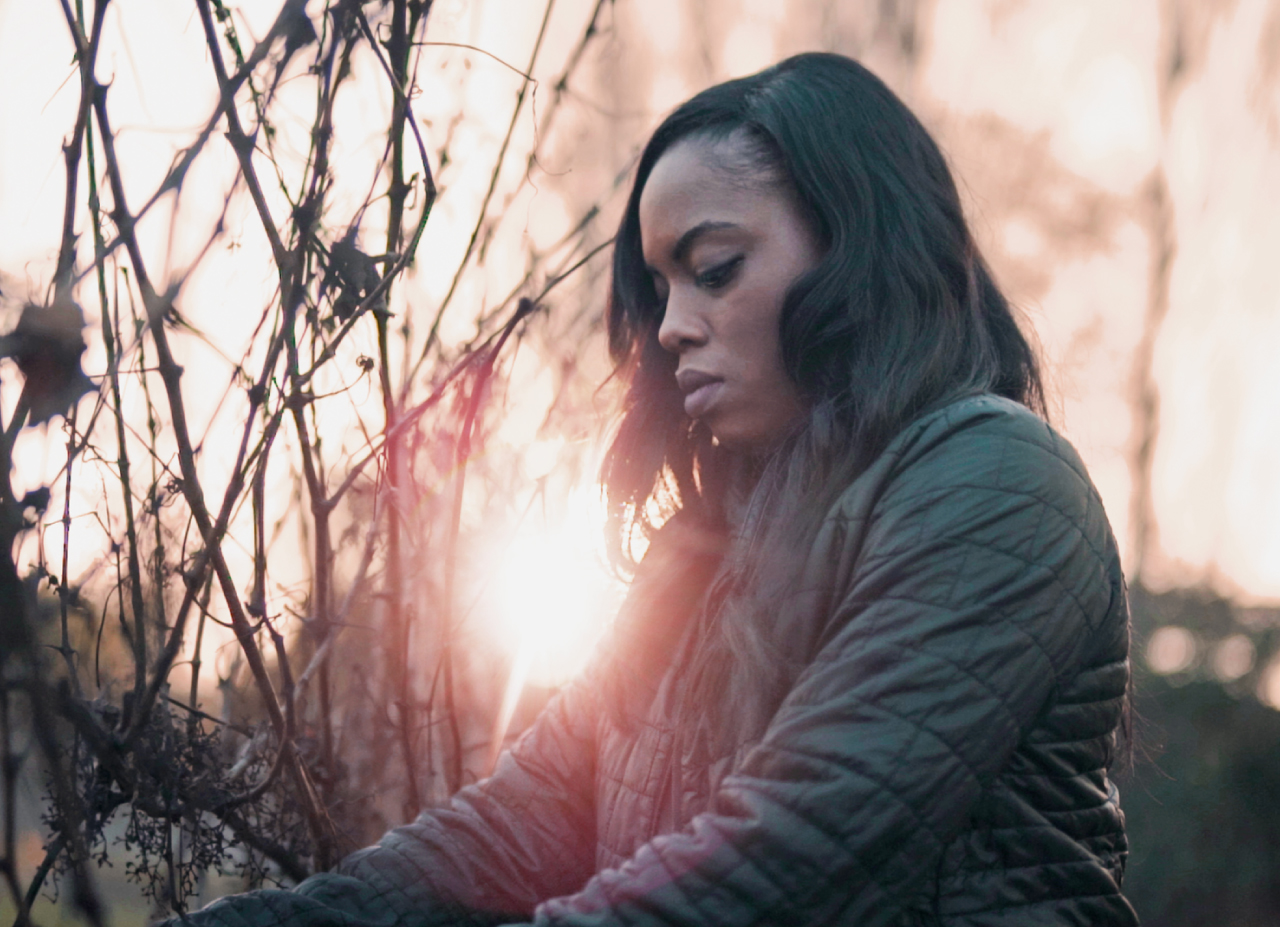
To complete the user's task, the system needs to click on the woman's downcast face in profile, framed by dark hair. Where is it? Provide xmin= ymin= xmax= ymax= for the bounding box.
xmin=640 ymin=136 xmax=822 ymax=451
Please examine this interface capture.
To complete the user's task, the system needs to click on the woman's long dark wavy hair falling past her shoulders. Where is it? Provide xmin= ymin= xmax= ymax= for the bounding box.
xmin=602 ymin=54 xmax=1044 ymax=737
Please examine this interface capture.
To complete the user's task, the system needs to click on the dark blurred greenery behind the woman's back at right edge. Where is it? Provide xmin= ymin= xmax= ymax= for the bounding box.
xmin=1120 ymin=589 xmax=1280 ymax=927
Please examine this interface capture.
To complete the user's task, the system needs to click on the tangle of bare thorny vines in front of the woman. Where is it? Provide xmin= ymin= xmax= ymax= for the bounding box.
xmin=0 ymin=0 xmax=619 ymax=927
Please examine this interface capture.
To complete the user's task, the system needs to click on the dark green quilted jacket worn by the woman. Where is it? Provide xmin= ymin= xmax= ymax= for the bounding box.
xmin=172 ymin=396 xmax=1137 ymax=927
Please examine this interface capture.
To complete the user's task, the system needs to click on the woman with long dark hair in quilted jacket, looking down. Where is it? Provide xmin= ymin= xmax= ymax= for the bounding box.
xmin=175 ymin=55 xmax=1137 ymax=927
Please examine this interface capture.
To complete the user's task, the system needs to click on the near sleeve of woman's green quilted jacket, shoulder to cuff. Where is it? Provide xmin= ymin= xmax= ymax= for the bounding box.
xmin=509 ymin=412 xmax=1124 ymax=927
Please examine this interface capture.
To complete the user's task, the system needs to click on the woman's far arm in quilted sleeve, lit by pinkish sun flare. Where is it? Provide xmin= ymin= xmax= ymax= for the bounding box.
xmin=170 ymin=517 xmax=721 ymax=927
